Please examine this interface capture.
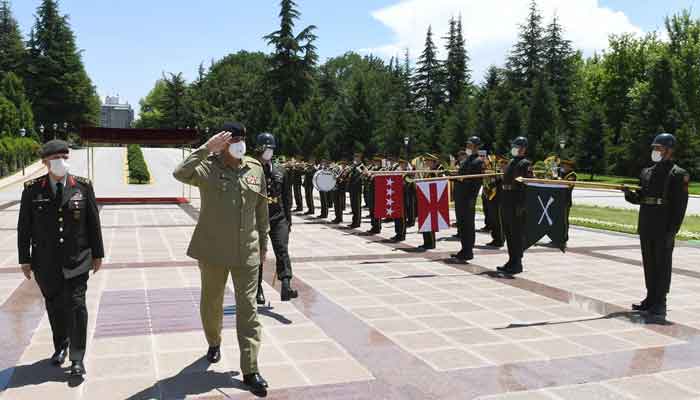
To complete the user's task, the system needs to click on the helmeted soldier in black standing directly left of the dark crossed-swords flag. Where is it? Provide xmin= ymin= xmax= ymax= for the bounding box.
xmin=498 ymin=136 xmax=532 ymax=275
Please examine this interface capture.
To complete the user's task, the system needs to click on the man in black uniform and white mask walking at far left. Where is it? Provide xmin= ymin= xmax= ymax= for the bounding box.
xmin=17 ymin=140 xmax=104 ymax=376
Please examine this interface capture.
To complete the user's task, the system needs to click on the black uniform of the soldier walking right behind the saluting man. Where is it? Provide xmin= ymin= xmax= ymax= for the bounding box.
xmin=258 ymin=162 xmax=296 ymax=304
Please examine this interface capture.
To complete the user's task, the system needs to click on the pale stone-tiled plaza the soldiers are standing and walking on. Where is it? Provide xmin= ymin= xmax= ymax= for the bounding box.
xmin=0 ymin=201 xmax=700 ymax=400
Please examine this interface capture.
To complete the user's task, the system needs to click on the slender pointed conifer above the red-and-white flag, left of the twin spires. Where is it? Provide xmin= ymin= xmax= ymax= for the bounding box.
xmin=414 ymin=26 xmax=445 ymax=121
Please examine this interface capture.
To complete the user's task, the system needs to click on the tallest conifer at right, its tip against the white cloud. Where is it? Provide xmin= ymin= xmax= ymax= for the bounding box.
xmin=507 ymin=0 xmax=544 ymax=90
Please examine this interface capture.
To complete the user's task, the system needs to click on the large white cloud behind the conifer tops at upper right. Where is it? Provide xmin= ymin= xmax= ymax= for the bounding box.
xmin=361 ymin=0 xmax=642 ymax=81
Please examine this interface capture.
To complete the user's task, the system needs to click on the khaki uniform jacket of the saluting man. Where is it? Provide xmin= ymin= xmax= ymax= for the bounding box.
xmin=173 ymin=146 xmax=270 ymax=267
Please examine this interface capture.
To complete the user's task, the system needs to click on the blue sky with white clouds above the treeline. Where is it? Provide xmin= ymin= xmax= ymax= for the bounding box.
xmin=12 ymin=0 xmax=700 ymax=117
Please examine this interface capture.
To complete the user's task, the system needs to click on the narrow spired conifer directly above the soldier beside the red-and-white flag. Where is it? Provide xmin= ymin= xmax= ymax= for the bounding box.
xmin=445 ymin=17 xmax=469 ymax=106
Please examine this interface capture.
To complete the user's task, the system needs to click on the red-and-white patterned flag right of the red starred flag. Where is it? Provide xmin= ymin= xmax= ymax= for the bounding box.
xmin=416 ymin=180 xmax=450 ymax=232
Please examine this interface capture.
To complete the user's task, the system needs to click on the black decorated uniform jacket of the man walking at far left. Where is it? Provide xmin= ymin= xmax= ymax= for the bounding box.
xmin=17 ymin=175 xmax=104 ymax=279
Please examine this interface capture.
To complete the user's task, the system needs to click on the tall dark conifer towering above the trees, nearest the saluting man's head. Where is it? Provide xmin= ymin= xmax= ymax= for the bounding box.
xmin=264 ymin=0 xmax=318 ymax=109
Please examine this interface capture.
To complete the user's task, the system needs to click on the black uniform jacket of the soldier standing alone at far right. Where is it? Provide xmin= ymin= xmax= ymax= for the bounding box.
xmin=625 ymin=161 xmax=690 ymax=238
